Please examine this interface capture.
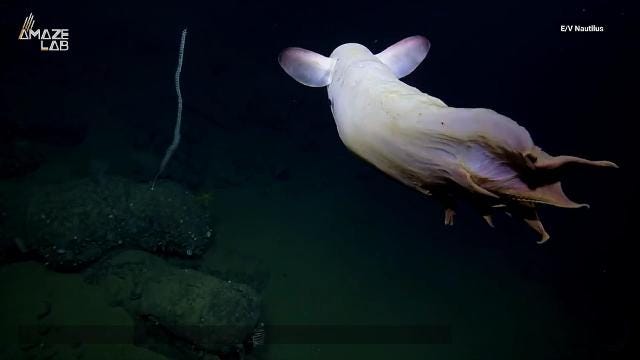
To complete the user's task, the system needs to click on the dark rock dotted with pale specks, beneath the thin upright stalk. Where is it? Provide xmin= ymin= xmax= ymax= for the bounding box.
xmin=24 ymin=177 xmax=214 ymax=270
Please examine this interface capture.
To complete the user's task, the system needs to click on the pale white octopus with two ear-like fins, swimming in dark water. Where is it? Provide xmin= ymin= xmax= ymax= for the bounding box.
xmin=280 ymin=36 xmax=616 ymax=242
